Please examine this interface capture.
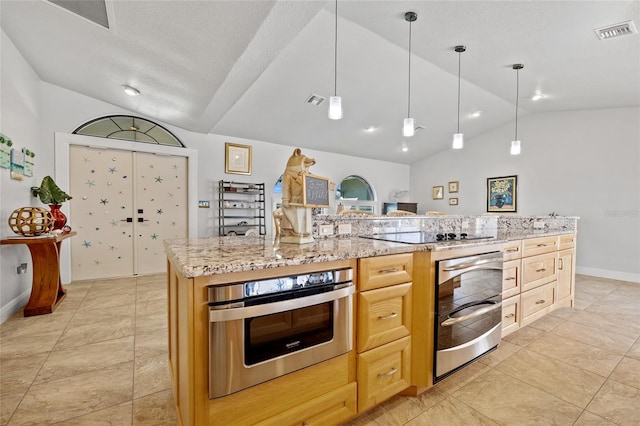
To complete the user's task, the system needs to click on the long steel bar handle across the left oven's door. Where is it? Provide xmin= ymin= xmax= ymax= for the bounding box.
xmin=209 ymin=285 xmax=356 ymax=322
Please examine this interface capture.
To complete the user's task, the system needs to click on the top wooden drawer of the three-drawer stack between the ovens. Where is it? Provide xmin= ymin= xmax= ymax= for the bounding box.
xmin=358 ymin=253 xmax=413 ymax=291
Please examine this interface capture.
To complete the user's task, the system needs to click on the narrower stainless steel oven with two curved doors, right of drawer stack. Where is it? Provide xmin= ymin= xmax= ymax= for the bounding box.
xmin=433 ymin=252 xmax=503 ymax=382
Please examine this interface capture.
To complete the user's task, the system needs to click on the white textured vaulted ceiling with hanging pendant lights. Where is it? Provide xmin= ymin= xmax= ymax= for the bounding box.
xmin=0 ymin=0 xmax=640 ymax=164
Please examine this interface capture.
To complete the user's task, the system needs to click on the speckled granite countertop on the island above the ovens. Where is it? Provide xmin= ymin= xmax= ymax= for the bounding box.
xmin=164 ymin=230 xmax=574 ymax=278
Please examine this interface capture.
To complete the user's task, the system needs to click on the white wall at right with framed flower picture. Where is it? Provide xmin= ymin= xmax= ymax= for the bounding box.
xmin=411 ymin=108 xmax=640 ymax=282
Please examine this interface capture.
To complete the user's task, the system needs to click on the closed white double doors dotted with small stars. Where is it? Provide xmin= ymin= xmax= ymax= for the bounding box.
xmin=69 ymin=145 xmax=188 ymax=281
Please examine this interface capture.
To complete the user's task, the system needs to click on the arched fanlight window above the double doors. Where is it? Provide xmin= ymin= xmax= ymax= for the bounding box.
xmin=73 ymin=115 xmax=184 ymax=148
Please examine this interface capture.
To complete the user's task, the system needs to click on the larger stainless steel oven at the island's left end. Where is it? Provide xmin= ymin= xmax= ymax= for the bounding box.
xmin=208 ymin=268 xmax=355 ymax=399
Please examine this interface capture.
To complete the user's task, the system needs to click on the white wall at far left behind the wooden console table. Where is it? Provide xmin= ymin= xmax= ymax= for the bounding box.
xmin=0 ymin=31 xmax=44 ymax=322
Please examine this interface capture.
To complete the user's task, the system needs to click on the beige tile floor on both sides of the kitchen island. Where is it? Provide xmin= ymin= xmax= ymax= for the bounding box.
xmin=0 ymin=276 xmax=640 ymax=426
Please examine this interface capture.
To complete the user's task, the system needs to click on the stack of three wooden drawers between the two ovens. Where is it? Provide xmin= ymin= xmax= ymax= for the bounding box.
xmin=356 ymin=253 xmax=413 ymax=413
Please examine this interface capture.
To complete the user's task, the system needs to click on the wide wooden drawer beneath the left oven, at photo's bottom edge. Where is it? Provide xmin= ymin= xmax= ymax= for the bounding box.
xmin=257 ymin=382 xmax=357 ymax=426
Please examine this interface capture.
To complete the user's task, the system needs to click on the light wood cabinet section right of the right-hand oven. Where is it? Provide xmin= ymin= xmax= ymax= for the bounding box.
xmin=502 ymin=234 xmax=576 ymax=337
